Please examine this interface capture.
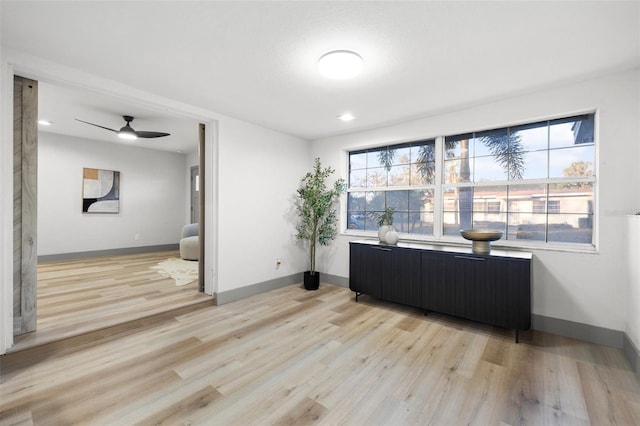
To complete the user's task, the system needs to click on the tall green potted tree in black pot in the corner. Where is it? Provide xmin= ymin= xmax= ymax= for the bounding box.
xmin=296 ymin=158 xmax=345 ymax=290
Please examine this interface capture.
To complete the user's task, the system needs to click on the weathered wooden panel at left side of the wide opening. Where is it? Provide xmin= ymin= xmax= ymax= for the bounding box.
xmin=13 ymin=76 xmax=38 ymax=335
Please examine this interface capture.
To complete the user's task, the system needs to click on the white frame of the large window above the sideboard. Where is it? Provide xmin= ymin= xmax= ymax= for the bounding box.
xmin=340 ymin=110 xmax=599 ymax=253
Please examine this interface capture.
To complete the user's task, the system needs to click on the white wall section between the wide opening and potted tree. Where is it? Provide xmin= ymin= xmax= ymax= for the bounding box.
xmin=217 ymin=119 xmax=312 ymax=292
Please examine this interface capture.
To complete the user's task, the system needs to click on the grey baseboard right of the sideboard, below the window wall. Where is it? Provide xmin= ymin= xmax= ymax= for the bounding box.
xmin=531 ymin=314 xmax=624 ymax=349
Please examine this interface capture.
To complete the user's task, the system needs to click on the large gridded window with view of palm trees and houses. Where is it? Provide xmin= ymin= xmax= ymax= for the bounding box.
xmin=347 ymin=114 xmax=595 ymax=244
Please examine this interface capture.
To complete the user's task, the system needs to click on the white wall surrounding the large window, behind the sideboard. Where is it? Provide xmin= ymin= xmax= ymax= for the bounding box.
xmin=312 ymin=70 xmax=640 ymax=330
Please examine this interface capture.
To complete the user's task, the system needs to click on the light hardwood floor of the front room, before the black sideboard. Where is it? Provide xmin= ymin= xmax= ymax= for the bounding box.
xmin=0 ymin=284 xmax=640 ymax=425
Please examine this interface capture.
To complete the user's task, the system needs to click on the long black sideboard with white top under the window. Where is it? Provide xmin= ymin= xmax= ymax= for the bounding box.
xmin=349 ymin=240 xmax=532 ymax=343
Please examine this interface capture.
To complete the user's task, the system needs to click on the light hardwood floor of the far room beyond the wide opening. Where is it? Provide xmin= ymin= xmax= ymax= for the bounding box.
xmin=11 ymin=250 xmax=213 ymax=352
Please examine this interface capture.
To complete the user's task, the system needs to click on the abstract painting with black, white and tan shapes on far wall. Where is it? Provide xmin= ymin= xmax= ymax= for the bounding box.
xmin=82 ymin=168 xmax=120 ymax=213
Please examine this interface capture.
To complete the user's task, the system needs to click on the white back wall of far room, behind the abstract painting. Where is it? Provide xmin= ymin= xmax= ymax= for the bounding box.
xmin=38 ymin=132 xmax=188 ymax=255
